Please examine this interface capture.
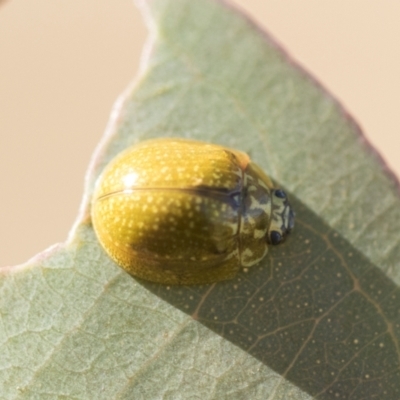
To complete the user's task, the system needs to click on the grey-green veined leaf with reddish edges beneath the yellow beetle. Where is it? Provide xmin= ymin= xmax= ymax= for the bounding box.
xmin=0 ymin=0 xmax=400 ymax=400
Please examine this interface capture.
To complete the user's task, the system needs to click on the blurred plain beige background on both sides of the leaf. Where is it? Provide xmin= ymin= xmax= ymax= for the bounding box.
xmin=0 ymin=0 xmax=400 ymax=266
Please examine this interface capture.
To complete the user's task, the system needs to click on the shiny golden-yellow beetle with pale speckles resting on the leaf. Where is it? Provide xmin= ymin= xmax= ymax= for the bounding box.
xmin=91 ymin=138 xmax=294 ymax=284
